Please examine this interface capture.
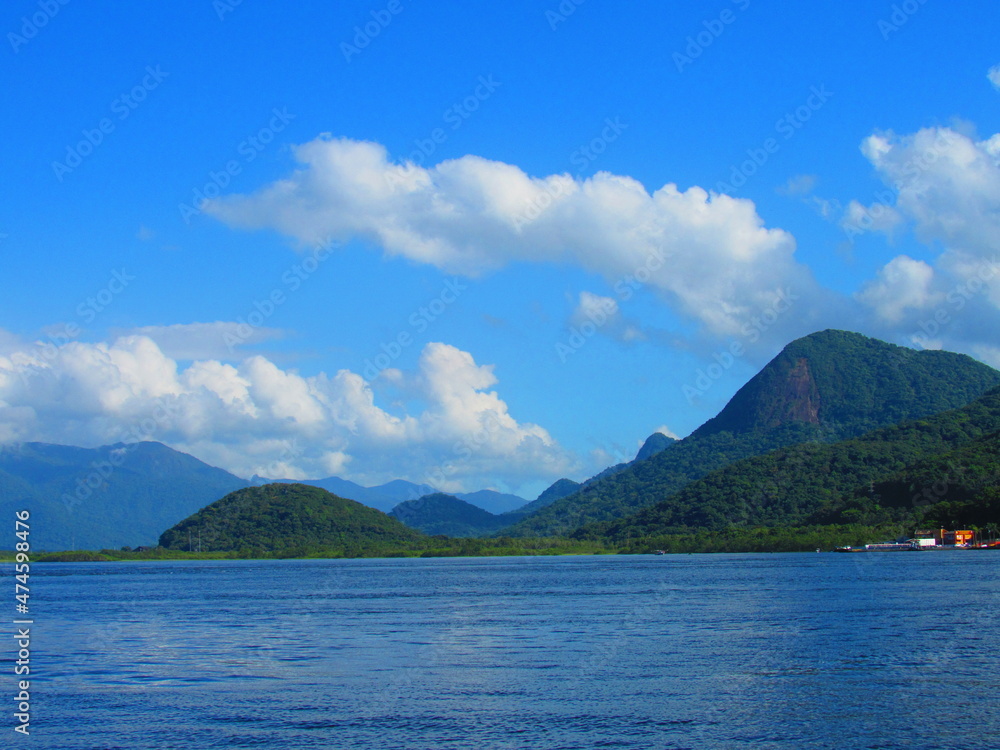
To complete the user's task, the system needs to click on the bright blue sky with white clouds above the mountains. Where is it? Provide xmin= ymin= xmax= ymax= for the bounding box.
xmin=0 ymin=0 xmax=1000 ymax=497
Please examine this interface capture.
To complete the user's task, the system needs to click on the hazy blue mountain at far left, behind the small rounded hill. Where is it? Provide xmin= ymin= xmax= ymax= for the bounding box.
xmin=0 ymin=442 xmax=247 ymax=550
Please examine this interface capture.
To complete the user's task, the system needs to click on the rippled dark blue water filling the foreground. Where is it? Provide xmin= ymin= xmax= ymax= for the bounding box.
xmin=11 ymin=551 xmax=1000 ymax=750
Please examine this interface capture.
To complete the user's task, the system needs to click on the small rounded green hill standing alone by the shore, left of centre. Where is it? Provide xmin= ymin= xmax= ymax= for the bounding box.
xmin=160 ymin=484 xmax=423 ymax=553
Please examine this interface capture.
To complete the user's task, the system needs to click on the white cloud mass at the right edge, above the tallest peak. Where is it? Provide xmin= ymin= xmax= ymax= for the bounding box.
xmin=857 ymin=128 xmax=1000 ymax=353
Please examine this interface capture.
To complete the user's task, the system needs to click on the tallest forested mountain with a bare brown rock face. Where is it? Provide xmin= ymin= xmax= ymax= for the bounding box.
xmin=502 ymin=330 xmax=1000 ymax=536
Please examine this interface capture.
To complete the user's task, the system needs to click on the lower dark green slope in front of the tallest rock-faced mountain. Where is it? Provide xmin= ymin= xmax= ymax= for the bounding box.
xmin=573 ymin=389 xmax=1000 ymax=541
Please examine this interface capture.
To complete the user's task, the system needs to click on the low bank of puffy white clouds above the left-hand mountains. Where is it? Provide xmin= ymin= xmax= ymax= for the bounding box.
xmin=0 ymin=335 xmax=581 ymax=491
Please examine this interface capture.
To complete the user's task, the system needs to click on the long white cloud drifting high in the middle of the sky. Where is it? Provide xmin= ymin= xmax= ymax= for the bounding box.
xmin=201 ymin=136 xmax=820 ymax=335
